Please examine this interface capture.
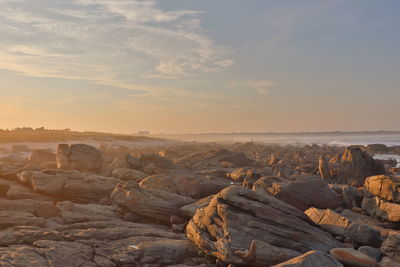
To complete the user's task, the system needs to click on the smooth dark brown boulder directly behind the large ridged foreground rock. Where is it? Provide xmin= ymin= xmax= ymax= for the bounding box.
xmin=253 ymin=176 xmax=341 ymax=211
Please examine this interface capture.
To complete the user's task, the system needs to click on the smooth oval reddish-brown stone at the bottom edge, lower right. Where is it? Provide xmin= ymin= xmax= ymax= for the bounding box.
xmin=329 ymin=248 xmax=378 ymax=267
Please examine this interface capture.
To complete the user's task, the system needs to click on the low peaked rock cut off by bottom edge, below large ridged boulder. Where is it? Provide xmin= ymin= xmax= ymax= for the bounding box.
xmin=273 ymin=250 xmax=343 ymax=267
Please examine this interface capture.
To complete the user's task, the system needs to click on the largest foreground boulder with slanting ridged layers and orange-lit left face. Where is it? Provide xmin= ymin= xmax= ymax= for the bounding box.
xmin=186 ymin=186 xmax=341 ymax=265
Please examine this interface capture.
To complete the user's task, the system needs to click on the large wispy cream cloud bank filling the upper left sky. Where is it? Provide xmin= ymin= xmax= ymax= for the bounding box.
xmin=0 ymin=0 xmax=234 ymax=98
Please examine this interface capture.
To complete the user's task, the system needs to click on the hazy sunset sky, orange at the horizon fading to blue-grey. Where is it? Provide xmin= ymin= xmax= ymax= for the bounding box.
xmin=0 ymin=0 xmax=400 ymax=133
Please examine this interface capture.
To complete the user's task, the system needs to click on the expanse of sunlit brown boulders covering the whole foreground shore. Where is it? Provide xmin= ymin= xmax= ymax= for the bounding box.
xmin=0 ymin=142 xmax=400 ymax=267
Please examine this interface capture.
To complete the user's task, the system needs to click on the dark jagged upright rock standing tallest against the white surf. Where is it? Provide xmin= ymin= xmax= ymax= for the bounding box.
xmin=338 ymin=146 xmax=385 ymax=186
